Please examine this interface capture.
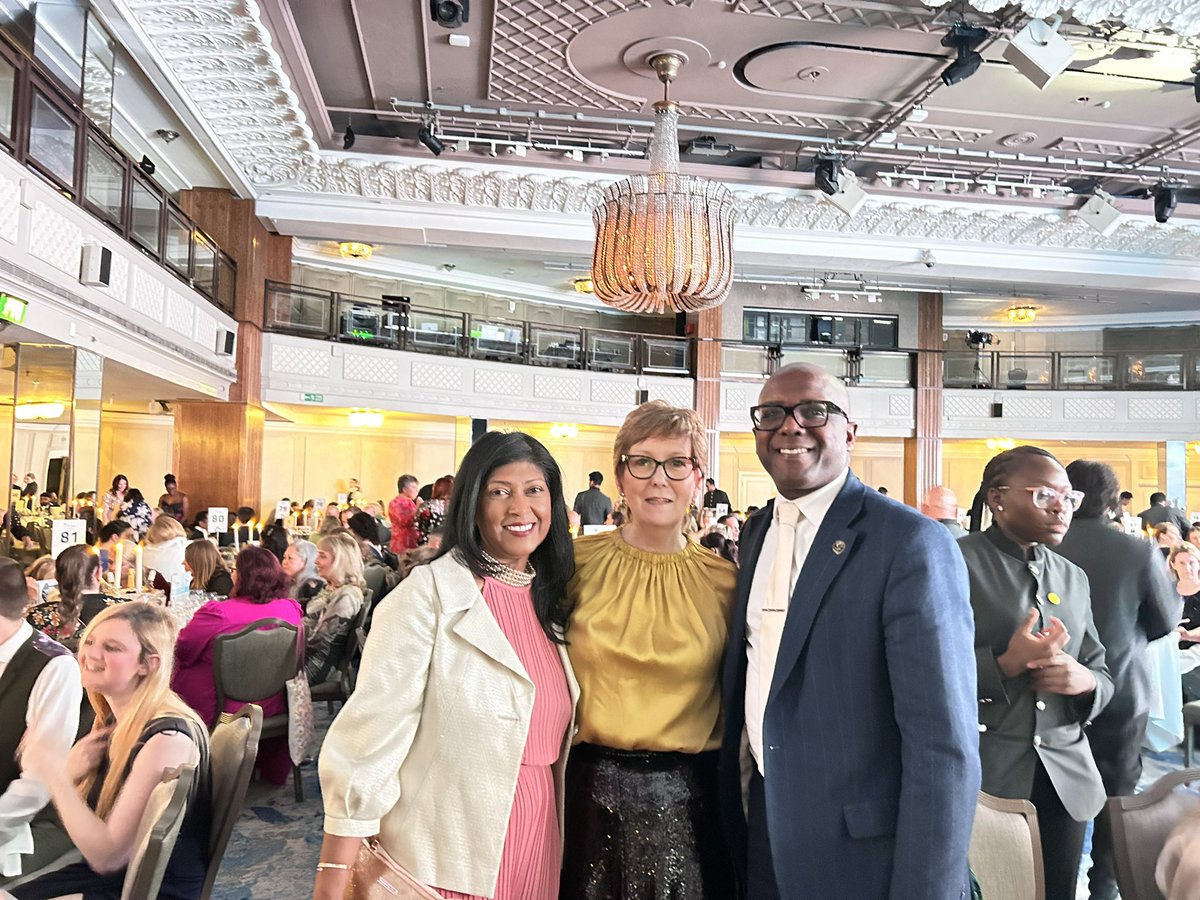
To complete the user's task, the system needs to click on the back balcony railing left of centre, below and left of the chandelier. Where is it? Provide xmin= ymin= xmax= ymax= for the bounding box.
xmin=263 ymin=281 xmax=694 ymax=376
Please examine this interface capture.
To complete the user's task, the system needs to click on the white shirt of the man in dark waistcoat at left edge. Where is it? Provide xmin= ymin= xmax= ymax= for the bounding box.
xmin=0 ymin=622 xmax=83 ymax=877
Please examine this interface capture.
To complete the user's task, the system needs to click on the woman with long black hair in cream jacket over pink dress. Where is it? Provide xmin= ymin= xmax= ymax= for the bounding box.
xmin=313 ymin=432 xmax=578 ymax=900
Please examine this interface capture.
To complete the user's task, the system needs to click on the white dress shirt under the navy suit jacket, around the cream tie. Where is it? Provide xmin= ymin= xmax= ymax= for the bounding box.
xmin=745 ymin=469 xmax=850 ymax=774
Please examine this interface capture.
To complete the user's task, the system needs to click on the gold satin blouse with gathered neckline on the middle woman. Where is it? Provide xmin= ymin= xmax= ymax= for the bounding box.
xmin=566 ymin=529 xmax=737 ymax=754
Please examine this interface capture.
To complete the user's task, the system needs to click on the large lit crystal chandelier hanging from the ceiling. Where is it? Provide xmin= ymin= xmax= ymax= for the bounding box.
xmin=592 ymin=53 xmax=734 ymax=313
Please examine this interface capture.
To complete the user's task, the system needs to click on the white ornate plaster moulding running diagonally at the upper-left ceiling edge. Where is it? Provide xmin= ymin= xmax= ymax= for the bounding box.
xmin=116 ymin=0 xmax=318 ymax=185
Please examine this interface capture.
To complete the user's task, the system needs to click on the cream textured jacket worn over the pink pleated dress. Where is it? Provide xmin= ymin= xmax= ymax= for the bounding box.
xmin=319 ymin=554 xmax=580 ymax=896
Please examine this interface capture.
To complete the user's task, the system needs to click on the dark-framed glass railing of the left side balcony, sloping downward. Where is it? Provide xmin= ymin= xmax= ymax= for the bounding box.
xmin=0 ymin=30 xmax=238 ymax=313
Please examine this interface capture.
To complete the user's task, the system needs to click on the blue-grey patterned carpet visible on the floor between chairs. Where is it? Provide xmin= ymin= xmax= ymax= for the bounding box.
xmin=212 ymin=704 xmax=1183 ymax=900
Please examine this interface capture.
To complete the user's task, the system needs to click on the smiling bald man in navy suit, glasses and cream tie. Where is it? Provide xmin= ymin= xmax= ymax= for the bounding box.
xmin=721 ymin=365 xmax=979 ymax=900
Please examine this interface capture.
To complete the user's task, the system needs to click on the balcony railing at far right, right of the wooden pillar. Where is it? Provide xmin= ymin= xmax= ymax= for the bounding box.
xmin=942 ymin=350 xmax=1200 ymax=390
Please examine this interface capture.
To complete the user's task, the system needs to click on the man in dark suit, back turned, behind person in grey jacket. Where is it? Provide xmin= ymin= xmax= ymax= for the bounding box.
xmin=1055 ymin=460 xmax=1183 ymax=900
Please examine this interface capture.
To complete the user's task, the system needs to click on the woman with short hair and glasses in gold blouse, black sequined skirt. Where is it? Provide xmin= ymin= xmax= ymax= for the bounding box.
xmin=560 ymin=401 xmax=737 ymax=900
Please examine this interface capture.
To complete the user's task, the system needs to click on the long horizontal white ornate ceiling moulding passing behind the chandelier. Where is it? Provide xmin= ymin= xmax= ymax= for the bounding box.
xmin=276 ymin=160 xmax=1200 ymax=258
